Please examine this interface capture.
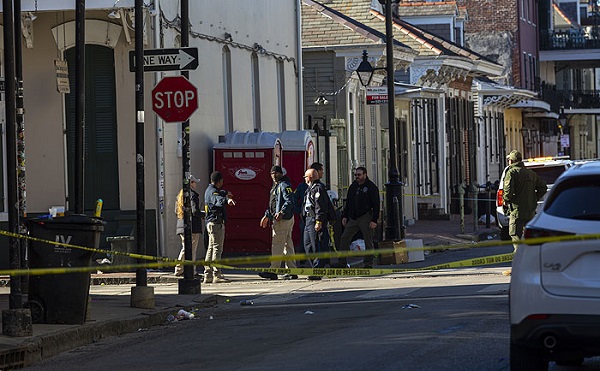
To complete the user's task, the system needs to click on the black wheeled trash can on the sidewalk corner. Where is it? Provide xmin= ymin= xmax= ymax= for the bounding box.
xmin=26 ymin=214 xmax=105 ymax=324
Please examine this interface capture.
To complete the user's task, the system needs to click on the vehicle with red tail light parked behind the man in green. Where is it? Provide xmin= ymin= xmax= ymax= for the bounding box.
xmin=496 ymin=156 xmax=573 ymax=241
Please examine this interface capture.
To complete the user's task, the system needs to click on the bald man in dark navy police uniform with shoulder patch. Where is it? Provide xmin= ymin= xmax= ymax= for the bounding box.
xmin=302 ymin=169 xmax=331 ymax=268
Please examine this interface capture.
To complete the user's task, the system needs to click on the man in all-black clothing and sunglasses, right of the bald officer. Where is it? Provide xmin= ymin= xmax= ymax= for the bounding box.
xmin=339 ymin=166 xmax=380 ymax=268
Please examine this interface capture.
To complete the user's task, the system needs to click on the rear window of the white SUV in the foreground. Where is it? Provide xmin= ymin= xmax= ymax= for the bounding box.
xmin=544 ymin=177 xmax=600 ymax=220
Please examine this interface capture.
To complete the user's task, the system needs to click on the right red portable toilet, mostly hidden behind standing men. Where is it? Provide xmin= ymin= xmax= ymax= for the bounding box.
xmin=277 ymin=130 xmax=315 ymax=253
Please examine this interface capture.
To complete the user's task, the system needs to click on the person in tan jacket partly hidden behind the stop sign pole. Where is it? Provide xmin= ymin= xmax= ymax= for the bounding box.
xmin=175 ymin=174 xmax=204 ymax=276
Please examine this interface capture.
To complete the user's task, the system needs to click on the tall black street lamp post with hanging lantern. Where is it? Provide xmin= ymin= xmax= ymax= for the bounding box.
xmin=356 ymin=0 xmax=404 ymax=240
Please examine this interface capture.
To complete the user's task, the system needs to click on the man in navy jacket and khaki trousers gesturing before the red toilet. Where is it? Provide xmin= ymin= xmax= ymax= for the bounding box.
xmin=202 ymin=171 xmax=235 ymax=283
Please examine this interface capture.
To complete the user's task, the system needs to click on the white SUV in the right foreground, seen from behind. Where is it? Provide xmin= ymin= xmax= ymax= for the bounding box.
xmin=509 ymin=161 xmax=600 ymax=370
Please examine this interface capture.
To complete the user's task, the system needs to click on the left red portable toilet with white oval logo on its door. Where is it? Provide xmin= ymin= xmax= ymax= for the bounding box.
xmin=213 ymin=131 xmax=282 ymax=255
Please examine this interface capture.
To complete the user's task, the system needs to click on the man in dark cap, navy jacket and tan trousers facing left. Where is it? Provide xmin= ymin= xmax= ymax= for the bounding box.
xmin=259 ymin=166 xmax=298 ymax=280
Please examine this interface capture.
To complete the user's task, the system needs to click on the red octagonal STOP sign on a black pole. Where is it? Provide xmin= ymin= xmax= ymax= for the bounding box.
xmin=152 ymin=76 xmax=198 ymax=122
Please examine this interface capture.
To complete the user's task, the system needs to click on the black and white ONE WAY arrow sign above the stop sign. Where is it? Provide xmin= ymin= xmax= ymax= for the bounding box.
xmin=129 ymin=48 xmax=198 ymax=72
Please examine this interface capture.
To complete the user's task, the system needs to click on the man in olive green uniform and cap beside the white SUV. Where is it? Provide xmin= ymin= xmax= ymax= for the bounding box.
xmin=502 ymin=150 xmax=548 ymax=251
